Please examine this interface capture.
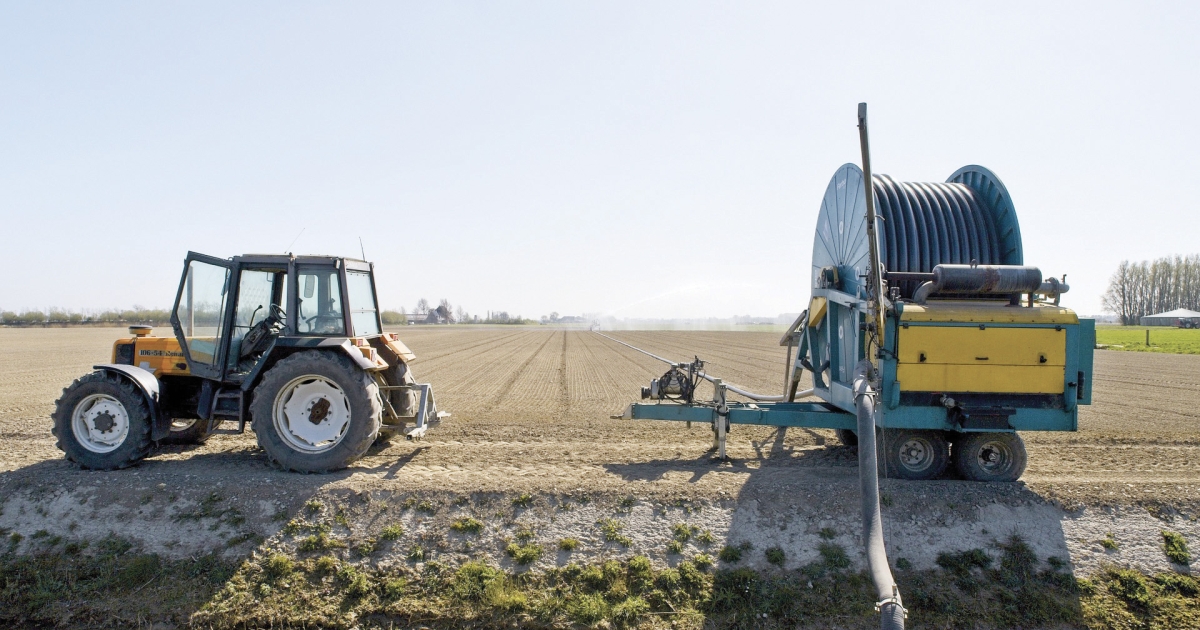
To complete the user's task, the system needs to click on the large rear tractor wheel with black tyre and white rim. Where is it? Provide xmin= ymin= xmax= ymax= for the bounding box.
xmin=250 ymin=350 xmax=383 ymax=473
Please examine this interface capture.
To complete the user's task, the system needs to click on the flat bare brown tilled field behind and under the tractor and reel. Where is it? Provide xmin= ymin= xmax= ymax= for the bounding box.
xmin=0 ymin=328 xmax=1200 ymax=506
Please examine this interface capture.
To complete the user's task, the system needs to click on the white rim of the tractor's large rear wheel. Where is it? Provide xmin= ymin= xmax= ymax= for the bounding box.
xmin=271 ymin=374 xmax=350 ymax=454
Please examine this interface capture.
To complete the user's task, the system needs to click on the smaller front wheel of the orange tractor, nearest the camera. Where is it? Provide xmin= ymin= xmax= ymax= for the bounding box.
xmin=53 ymin=371 xmax=151 ymax=470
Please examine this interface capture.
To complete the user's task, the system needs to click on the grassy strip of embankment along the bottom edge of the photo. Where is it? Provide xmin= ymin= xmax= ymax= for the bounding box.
xmin=0 ymin=538 xmax=1200 ymax=629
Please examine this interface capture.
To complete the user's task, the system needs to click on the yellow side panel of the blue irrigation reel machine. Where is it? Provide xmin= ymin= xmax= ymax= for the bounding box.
xmin=896 ymin=301 xmax=1079 ymax=394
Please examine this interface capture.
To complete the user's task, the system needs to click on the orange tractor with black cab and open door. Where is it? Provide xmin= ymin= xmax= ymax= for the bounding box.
xmin=53 ymin=252 xmax=449 ymax=473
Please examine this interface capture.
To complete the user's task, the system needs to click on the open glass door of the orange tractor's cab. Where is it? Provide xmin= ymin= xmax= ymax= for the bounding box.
xmin=170 ymin=252 xmax=234 ymax=380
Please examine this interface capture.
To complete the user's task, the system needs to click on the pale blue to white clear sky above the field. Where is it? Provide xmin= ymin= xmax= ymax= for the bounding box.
xmin=0 ymin=1 xmax=1200 ymax=318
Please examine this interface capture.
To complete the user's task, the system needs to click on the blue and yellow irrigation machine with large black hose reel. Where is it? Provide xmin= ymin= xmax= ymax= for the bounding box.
xmin=610 ymin=104 xmax=1096 ymax=481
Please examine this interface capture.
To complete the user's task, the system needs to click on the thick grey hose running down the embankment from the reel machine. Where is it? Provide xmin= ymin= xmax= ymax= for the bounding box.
xmin=854 ymin=361 xmax=906 ymax=630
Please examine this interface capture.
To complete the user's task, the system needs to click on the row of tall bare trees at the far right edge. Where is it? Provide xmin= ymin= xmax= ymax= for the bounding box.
xmin=1102 ymin=254 xmax=1200 ymax=326
